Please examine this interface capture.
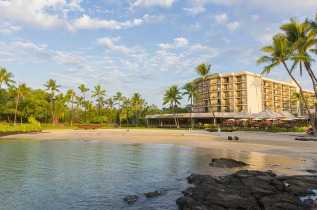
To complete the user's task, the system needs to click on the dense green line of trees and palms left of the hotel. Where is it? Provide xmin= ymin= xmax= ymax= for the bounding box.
xmin=0 ymin=67 xmax=189 ymax=126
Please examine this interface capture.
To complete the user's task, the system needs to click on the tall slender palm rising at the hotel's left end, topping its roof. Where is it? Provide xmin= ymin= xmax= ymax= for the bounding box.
xmin=196 ymin=63 xmax=216 ymax=124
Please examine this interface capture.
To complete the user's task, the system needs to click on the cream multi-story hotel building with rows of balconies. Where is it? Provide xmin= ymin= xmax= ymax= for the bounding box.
xmin=193 ymin=71 xmax=316 ymax=115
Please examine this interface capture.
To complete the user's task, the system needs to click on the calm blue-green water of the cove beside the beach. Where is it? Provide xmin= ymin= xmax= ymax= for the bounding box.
xmin=0 ymin=140 xmax=317 ymax=209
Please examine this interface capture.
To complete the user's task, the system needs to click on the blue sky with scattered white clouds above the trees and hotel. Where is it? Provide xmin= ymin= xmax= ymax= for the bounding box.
xmin=0 ymin=0 xmax=317 ymax=107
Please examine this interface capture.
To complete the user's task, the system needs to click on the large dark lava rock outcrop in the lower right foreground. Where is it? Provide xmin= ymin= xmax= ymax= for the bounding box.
xmin=176 ymin=170 xmax=317 ymax=210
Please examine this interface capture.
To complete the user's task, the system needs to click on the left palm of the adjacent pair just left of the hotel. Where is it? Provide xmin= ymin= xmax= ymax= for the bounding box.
xmin=163 ymin=85 xmax=182 ymax=128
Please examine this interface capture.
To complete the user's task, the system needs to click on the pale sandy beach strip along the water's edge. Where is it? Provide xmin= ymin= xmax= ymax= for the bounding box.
xmin=0 ymin=129 xmax=317 ymax=161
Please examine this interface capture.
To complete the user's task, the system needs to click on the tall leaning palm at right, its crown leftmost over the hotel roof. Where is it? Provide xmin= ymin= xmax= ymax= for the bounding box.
xmin=257 ymin=34 xmax=317 ymax=136
